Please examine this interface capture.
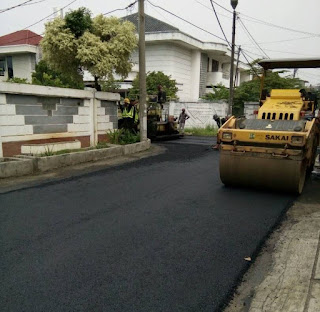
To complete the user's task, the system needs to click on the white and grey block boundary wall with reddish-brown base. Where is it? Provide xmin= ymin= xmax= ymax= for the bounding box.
xmin=0 ymin=83 xmax=120 ymax=157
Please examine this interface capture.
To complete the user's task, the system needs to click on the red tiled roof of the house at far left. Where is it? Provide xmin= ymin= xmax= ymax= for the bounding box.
xmin=0 ymin=30 xmax=42 ymax=46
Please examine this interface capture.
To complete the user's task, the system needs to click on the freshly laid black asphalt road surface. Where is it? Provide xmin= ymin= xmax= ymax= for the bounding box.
xmin=0 ymin=137 xmax=294 ymax=311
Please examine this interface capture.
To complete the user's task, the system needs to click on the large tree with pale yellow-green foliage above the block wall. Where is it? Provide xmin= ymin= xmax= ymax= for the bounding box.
xmin=41 ymin=8 xmax=137 ymax=89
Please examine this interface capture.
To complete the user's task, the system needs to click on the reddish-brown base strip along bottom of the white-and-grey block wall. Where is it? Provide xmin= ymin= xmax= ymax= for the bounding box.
xmin=2 ymin=136 xmax=90 ymax=157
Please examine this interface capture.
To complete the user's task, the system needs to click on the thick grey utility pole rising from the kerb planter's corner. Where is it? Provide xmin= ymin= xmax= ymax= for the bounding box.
xmin=138 ymin=0 xmax=147 ymax=142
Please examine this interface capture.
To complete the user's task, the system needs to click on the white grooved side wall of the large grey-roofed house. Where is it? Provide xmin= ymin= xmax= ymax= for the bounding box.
xmin=132 ymin=43 xmax=192 ymax=101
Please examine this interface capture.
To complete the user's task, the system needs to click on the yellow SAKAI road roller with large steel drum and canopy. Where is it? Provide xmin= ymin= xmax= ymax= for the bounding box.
xmin=218 ymin=59 xmax=320 ymax=194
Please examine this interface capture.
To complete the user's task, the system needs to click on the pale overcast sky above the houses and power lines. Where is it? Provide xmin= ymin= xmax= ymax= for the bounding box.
xmin=0 ymin=0 xmax=320 ymax=84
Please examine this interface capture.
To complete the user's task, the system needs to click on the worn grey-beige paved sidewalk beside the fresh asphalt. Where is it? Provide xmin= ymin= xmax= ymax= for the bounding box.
xmin=225 ymin=164 xmax=320 ymax=312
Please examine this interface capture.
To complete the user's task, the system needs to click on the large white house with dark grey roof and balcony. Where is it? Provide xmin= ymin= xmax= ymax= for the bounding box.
xmin=122 ymin=13 xmax=251 ymax=101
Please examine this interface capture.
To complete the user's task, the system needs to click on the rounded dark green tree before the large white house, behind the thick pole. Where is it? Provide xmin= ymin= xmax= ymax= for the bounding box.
xmin=129 ymin=71 xmax=178 ymax=98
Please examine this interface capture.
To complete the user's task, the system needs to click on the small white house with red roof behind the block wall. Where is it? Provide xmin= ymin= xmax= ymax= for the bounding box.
xmin=0 ymin=30 xmax=42 ymax=82
